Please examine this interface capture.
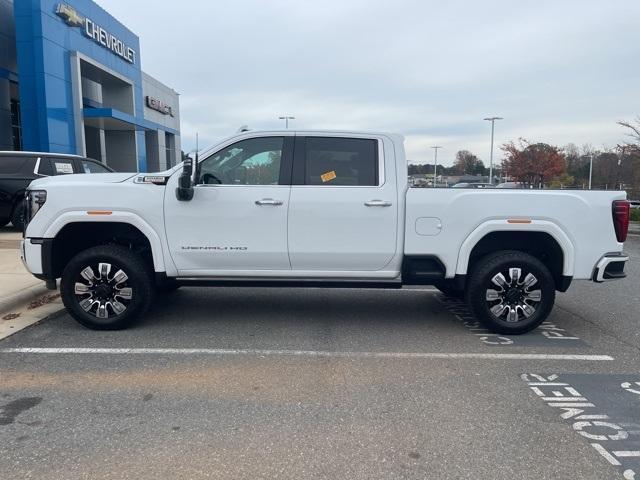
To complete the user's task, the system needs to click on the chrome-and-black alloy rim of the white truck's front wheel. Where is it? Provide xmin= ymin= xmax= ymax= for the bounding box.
xmin=74 ymin=263 xmax=133 ymax=318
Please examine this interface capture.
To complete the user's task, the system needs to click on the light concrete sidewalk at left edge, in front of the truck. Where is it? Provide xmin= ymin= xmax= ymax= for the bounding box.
xmin=0 ymin=228 xmax=62 ymax=339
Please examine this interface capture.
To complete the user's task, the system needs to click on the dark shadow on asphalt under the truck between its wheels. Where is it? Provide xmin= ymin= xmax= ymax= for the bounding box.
xmin=140 ymin=288 xmax=455 ymax=328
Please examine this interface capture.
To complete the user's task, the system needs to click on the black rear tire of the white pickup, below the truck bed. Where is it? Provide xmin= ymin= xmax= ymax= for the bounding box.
xmin=467 ymin=250 xmax=556 ymax=335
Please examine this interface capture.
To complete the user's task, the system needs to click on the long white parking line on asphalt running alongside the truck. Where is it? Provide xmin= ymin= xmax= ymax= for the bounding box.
xmin=0 ymin=347 xmax=613 ymax=362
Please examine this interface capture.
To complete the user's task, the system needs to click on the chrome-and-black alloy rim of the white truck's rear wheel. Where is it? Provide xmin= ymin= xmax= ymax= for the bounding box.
xmin=485 ymin=268 xmax=542 ymax=323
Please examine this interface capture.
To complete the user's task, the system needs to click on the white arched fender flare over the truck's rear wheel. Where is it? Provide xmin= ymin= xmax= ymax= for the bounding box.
xmin=456 ymin=219 xmax=575 ymax=277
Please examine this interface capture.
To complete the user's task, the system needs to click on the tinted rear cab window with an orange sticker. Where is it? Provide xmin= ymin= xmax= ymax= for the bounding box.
xmin=294 ymin=136 xmax=380 ymax=187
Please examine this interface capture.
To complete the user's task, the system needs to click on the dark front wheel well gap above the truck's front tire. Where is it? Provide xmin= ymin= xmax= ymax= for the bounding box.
xmin=51 ymin=222 xmax=153 ymax=278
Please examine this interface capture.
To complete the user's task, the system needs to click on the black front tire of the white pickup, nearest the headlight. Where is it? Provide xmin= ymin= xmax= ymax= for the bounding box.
xmin=60 ymin=245 xmax=153 ymax=330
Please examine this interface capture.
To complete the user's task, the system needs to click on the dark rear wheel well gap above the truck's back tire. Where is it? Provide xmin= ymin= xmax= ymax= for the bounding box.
xmin=467 ymin=232 xmax=568 ymax=290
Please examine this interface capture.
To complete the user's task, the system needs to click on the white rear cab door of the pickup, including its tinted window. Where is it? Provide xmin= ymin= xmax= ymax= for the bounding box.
xmin=289 ymin=134 xmax=398 ymax=276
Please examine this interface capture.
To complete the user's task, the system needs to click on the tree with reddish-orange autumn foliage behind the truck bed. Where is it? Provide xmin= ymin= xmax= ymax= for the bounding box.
xmin=501 ymin=139 xmax=565 ymax=185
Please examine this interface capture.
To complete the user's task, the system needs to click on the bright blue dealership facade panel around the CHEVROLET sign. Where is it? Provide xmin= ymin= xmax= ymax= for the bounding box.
xmin=14 ymin=0 xmax=146 ymax=170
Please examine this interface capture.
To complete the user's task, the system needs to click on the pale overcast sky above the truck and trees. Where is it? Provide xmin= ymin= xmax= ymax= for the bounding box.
xmin=98 ymin=0 xmax=640 ymax=165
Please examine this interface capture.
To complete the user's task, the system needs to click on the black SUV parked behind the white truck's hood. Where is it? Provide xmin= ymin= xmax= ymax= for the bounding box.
xmin=0 ymin=152 xmax=113 ymax=229
